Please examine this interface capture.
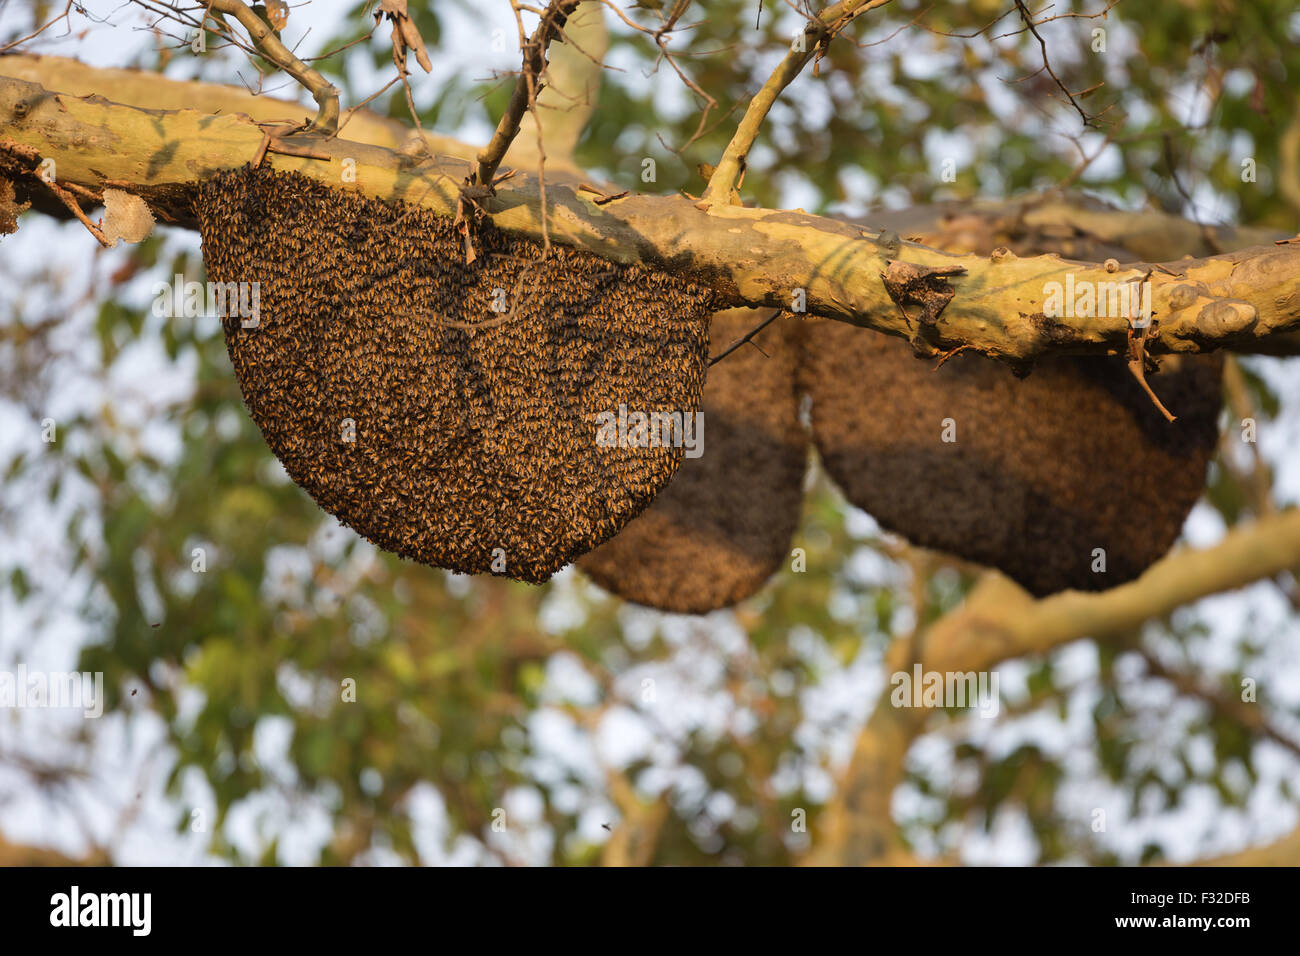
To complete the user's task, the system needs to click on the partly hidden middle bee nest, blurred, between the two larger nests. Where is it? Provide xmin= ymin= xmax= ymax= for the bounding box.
xmin=577 ymin=310 xmax=807 ymax=614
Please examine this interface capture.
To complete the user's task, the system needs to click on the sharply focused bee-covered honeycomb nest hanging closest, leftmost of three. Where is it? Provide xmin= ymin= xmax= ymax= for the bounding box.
xmin=195 ymin=168 xmax=711 ymax=583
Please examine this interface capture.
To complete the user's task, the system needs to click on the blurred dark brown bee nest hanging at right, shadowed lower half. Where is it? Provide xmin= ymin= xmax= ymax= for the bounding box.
xmin=801 ymin=321 xmax=1222 ymax=596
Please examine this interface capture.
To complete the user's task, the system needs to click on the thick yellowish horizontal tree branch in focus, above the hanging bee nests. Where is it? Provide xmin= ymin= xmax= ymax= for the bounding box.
xmin=0 ymin=71 xmax=1300 ymax=363
